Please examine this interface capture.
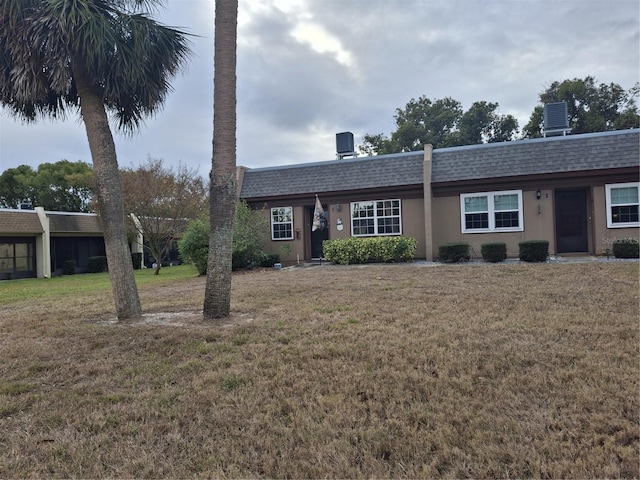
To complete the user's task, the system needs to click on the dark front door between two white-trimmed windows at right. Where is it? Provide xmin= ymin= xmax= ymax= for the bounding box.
xmin=555 ymin=188 xmax=589 ymax=253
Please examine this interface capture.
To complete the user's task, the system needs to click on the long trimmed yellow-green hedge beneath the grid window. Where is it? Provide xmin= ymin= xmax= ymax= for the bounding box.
xmin=322 ymin=237 xmax=418 ymax=265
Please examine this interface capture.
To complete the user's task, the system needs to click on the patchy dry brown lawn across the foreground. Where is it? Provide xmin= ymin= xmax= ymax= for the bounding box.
xmin=0 ymin=262 xmax=640 ymax=478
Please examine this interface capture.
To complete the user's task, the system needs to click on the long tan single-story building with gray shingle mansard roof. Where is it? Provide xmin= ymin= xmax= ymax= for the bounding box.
xmin=238 ymin=129 xmax=640 ymax=264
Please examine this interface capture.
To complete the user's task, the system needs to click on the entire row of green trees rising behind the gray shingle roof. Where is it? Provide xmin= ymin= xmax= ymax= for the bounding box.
xmin=358 ymin=76 xmax=640 ymax=155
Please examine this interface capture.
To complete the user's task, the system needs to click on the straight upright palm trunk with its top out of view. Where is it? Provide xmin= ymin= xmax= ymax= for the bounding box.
xmin=203 ymin=0 xmax=238 ymax=319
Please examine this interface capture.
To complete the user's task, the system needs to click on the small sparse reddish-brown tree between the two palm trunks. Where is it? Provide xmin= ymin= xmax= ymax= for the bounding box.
xmin=120 ymin=158 xmax=207 ymax=275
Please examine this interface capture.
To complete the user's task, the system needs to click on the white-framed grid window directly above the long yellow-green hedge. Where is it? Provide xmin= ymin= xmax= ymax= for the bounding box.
xmin=351 ymin=199 xmax=402 ymax=237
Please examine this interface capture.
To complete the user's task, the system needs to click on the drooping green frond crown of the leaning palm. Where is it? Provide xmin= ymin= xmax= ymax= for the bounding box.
xmin=0 ymin=0 xmax=190 ymax=133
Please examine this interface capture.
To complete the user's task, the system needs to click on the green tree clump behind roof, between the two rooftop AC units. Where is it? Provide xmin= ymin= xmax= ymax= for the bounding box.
xmin=358 ymin=96 xmax=518 ymax=155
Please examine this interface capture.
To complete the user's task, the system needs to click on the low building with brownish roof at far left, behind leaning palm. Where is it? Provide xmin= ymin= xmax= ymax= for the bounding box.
xmin=0 ymin=207 xmax=146 ymax=280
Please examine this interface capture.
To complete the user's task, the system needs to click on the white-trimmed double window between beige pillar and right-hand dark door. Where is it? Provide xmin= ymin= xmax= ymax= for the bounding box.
xmin=460 ymin=190 xmax=524 ymax=233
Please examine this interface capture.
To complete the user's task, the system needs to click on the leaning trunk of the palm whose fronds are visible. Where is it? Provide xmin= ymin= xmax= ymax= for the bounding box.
xmin=74 ymin=62 xmax=142 ymax=320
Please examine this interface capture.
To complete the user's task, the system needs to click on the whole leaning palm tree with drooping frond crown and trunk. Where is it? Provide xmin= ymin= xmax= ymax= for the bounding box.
xmin=0 ymin=0 xmax=190 ymax=320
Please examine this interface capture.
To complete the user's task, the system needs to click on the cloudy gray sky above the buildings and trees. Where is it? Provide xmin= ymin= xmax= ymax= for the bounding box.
xmin=0 ymin=0 xmax=640 ymax=177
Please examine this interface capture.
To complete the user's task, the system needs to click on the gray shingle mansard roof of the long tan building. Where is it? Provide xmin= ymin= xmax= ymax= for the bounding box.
xmin=240 ymin=129 xmax=640 ymax=199
